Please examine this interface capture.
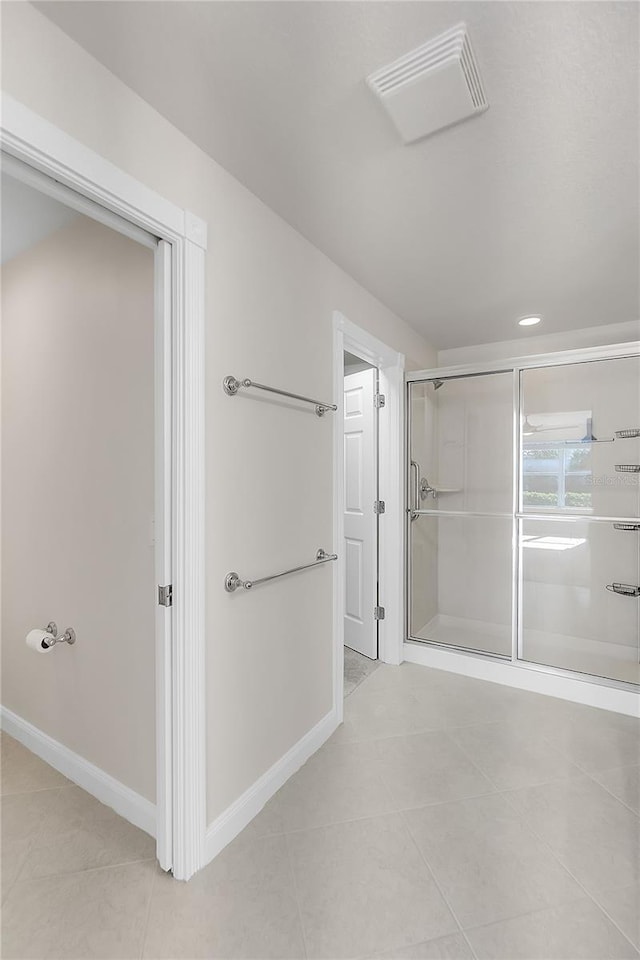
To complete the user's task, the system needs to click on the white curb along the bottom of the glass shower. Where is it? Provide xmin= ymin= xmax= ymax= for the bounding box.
xmin=404 ymin=642 xmax=640 ymax=717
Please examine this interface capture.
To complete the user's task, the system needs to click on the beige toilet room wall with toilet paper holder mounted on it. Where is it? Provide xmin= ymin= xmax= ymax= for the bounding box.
xmin=2 ymin=217 xmax=155 ymax=801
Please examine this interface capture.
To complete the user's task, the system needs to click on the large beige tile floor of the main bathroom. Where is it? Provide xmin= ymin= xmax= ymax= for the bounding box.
xmin=0 ymin=664 xmax=640 ymax=960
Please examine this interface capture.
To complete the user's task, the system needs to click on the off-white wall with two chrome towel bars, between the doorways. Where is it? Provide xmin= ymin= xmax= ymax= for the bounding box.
xmin=3 ymin=4 xmax=435 ymax=820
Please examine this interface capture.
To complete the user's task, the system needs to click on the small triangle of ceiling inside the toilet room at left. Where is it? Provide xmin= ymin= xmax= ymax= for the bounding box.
xmin=0 ymin=173 xmax=78 ymax=264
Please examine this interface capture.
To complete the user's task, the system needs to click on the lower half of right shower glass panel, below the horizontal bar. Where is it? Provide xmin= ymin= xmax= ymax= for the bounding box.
xmin=520 ymin=518 xmax=640 ymax=683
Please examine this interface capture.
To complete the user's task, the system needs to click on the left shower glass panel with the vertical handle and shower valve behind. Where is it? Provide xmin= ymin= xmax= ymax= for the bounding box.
xmin=408 ymin=372 xmax=513 ymax=657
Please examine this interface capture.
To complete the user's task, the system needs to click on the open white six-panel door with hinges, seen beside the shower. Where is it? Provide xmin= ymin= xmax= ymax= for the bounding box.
xmin=344 ymin=369 xmax=378 ymax=660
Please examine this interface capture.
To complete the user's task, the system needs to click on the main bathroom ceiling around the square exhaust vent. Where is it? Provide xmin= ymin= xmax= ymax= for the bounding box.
xmin=36 ymin=0 xmax=639 ymax=348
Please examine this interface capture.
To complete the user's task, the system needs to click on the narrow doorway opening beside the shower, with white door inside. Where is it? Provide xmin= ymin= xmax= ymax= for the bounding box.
xmin=342 ymin=350 xmax=384 ymax=697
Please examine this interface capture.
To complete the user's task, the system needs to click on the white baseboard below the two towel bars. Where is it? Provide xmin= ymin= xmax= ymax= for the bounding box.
xmin=204 ymin=709 xmax=340 ymax=864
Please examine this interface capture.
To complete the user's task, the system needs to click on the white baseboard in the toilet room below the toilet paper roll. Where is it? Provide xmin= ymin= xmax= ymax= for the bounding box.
xmin=0 ymin=706 xmax=156 ymax=837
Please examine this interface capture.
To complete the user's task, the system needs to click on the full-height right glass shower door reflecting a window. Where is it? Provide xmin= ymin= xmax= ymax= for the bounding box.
xmin=518 ymin=357 xmax=640 ymax=684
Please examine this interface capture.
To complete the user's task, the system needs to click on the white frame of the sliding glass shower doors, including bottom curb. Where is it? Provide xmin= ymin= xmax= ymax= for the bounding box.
xmin=403 ymin=340 xmax=640 ymax=715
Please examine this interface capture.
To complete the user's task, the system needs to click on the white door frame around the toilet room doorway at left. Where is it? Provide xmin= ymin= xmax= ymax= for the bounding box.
xmin=0 ymin=94 xmax=207 ymax=880
